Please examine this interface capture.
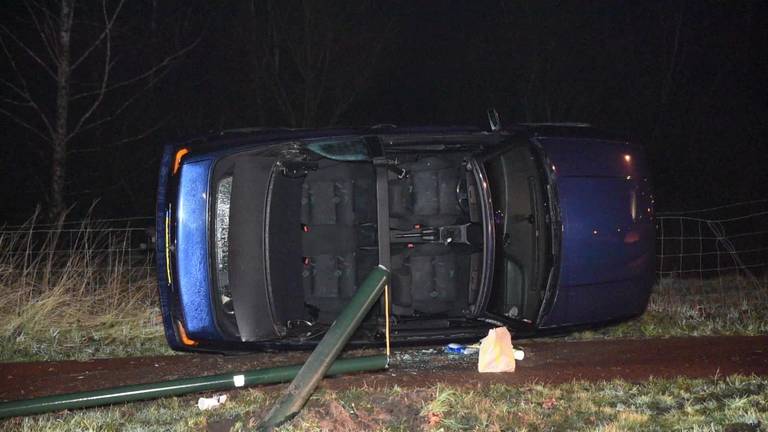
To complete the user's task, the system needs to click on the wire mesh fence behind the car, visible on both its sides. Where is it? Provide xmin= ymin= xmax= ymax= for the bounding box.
xmin=0 ymin=199 xmax=768 ymax=301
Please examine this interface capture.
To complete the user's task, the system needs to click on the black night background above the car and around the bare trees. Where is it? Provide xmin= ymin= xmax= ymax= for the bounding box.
xmin=0 ymin=0 xmax=768 ymax=221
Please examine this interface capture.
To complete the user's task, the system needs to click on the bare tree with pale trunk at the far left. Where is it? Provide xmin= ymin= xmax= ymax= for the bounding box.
xmin=0 ymin=0 xmax=196 ymax=219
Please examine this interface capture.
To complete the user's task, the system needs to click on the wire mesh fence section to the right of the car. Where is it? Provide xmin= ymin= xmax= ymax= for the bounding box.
xmin=656 ymin=200 xmax=768 ymax=303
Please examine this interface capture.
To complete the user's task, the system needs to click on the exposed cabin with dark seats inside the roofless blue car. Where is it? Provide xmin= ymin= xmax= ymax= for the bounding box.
xmin=201 ymin=140 xmax=546 ymax=350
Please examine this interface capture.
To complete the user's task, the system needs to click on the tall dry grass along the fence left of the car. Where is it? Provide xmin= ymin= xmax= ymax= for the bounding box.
xmin=0 ymin=213 xmax=169 ymax=361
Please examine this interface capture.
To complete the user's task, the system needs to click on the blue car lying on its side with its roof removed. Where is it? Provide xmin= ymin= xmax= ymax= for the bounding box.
xmin=156 ymin=124 xmax=655 ymax=352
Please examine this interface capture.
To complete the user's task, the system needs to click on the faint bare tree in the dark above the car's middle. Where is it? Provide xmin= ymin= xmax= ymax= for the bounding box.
xmin=246 ymin=0 xmax=389 ymax=127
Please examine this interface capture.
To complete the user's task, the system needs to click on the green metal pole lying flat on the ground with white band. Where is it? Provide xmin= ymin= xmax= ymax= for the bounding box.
xmin=0 ymin=355 xmax=387 ymax=418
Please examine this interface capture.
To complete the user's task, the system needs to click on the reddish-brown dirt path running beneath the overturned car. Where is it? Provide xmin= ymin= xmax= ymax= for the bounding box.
xmin=0 ymin=336 xmax=768 ymax=402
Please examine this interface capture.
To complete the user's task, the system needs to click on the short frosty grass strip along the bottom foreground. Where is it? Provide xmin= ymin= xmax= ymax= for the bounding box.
xmin=0 ymin=376 xmax=768 ymax=432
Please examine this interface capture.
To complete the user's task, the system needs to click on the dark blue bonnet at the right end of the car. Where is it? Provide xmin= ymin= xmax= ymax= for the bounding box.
xmin=538 ymin=138 xmax=655 ymax=327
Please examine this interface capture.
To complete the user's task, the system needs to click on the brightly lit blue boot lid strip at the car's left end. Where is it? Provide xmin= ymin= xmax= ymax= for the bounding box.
xmin=175 ymin=159 xmax=222 ymax=340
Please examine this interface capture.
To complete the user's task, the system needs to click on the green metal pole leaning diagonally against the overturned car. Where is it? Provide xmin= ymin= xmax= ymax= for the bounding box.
xmin=258 ymin=265 xmax=389 ymax=430
